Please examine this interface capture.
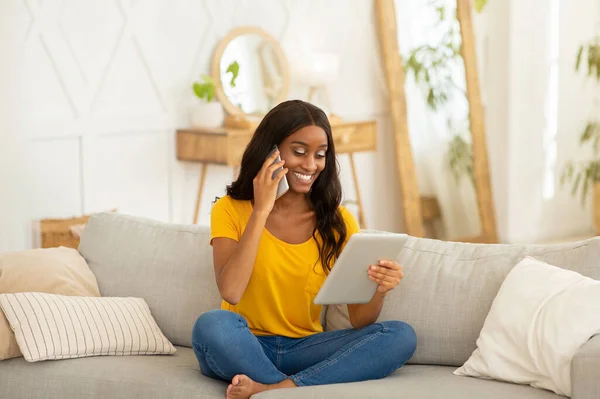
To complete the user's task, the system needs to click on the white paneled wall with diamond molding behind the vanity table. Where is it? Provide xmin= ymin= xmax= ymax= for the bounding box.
xmin=0 ymin=0 xmax=401 ymax=250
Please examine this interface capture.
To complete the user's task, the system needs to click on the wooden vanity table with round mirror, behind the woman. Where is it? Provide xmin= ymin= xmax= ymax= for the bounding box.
xmin=177 ymin=27 xmax=377 ymax=227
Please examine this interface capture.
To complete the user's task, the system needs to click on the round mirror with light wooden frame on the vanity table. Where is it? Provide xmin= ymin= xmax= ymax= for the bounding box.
xmin=212 ymin=27 xmax=289 ymax=117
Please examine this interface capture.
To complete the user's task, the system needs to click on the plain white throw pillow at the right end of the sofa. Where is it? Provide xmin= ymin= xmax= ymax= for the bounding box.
xmin=454 ymin=257 xmax=600 ymax=396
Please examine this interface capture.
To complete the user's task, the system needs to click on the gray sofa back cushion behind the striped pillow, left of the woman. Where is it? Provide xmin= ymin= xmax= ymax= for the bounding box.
xmin=79 ymin=213 xmax=220 ymax=347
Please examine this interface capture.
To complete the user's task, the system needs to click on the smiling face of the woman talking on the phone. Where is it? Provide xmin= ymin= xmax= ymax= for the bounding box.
xmin=279 ymin=126 xmax=327 ymax=193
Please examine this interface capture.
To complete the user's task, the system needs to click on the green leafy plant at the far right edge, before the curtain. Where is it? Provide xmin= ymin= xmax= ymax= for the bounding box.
xmin=561 ymin=37 xmax=600 ymax=235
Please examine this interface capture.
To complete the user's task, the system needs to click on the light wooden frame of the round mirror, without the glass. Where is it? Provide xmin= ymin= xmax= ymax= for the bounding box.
xmin=211 ymin=26 xmax=290 ymax=117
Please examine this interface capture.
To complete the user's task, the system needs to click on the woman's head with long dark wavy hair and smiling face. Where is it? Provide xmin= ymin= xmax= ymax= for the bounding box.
xmin=227 ymin=100 xmax=346 ymax=276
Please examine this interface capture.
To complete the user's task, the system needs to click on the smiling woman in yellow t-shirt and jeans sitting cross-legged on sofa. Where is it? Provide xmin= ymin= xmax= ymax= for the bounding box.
xmin=192 ymin=100 xmax=416 ymax=398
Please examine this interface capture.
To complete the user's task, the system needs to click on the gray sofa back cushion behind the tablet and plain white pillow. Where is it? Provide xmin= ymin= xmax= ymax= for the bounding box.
xmin=326 ymin=237 xmax=600 ymax=366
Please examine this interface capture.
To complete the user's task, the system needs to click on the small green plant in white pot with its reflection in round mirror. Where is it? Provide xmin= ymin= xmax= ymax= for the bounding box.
xmin=190 ymin=61 xmax=240 ymax=129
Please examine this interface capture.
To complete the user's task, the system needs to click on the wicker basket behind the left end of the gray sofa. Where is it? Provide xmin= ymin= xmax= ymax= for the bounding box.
xmin=34 ymin=209 xmax=117 ymax=249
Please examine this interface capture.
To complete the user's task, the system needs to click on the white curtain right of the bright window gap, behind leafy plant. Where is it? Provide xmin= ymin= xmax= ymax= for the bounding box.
xmin=540 ymin=0 xmax=600 ymax=238
